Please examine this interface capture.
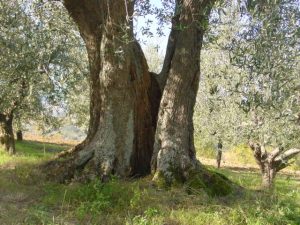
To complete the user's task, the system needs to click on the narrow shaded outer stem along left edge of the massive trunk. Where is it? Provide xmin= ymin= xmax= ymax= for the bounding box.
xmin=58 ymin=0 xmax=104 ymax=157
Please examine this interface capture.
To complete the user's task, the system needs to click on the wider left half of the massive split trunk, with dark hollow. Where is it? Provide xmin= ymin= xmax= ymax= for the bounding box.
xmin=50 ymin=0 xmax=157 ymax=179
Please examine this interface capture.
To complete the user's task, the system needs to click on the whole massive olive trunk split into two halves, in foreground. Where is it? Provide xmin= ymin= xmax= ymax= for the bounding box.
xmin=51 ymin=0 xmax=231 ymax=195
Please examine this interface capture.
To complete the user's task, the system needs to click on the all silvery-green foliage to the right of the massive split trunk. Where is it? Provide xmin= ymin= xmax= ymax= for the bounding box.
xmin=194 ymin=1 xmax=300 ymax=168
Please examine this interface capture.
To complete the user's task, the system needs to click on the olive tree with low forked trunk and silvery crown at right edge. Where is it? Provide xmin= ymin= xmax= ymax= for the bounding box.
xmin=232 ymin=1 xmax=300 ymax=187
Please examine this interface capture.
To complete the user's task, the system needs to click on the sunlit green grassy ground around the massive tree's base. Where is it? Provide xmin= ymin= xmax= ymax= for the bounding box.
xmin=0 ymin=141 xmax=300 ymax=225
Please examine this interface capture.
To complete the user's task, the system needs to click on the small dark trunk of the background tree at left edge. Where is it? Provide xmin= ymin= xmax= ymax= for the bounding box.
xmin=0 ymin=113 xmax=16 ymax=155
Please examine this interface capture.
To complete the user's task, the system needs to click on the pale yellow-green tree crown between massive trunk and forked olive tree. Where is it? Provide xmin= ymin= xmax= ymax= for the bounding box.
xmin=194 ymin=3 xmax=245 ymax=162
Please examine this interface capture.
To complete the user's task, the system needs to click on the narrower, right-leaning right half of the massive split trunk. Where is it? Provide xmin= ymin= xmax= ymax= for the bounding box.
xmin=152 ymin=0 xmax=213 ymax=183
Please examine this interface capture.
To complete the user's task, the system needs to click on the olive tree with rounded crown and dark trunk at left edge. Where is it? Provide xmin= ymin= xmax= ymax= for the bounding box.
xmin=0 ymin=0 xmax=85 ymax=154
